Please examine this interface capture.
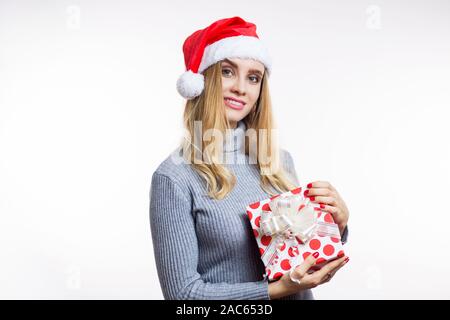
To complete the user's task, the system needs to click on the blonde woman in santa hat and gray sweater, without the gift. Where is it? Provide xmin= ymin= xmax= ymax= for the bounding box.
xmin=150 ymin=17 xmax=348 ymax=299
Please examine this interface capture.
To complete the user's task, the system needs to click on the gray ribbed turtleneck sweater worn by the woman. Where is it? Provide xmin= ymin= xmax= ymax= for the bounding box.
xmin=150 ymin=121 xmax=346 ymax=300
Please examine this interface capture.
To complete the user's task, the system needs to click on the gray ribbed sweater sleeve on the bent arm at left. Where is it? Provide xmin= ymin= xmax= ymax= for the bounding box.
xmin=150 ymin=172 xmax=269 ymax=300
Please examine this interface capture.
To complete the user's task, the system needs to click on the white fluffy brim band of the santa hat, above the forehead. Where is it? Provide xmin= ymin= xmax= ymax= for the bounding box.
xmin=198 ymin=36 xmax=272 ymax=74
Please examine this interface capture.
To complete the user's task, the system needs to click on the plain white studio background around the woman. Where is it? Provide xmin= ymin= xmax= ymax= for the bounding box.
xmin=0 ymin=0 xmax=450 ymax=299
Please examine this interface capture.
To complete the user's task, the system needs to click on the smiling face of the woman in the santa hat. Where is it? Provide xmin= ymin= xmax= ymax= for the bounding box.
xmin=221 ymin=58 xmax=264 ymax=128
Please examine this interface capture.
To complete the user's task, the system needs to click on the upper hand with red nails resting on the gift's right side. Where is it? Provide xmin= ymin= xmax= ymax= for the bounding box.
xmin=303 ymin=181 xmax=349 ymax=235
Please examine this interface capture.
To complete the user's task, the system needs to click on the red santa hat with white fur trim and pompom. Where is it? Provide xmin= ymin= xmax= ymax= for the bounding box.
xmin=177 ymin=17 xmax=271 ymax=99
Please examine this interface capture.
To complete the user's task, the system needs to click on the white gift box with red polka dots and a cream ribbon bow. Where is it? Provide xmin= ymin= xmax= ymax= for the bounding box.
xmin=246 ymin=187 xmax=345 ymax=281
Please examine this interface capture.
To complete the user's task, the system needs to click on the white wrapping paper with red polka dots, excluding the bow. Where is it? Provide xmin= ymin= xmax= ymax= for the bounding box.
xmin=246 ymin=187 xmax=345 ymax=281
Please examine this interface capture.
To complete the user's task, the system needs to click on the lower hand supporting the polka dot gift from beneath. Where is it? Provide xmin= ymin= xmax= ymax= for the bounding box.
xmin=269 ymin=254 xmax=349 ymax=299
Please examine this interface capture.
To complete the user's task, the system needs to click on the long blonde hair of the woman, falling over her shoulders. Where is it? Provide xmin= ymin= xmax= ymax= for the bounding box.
xmin=182 ymin=61 xmax=295 ymax=199
